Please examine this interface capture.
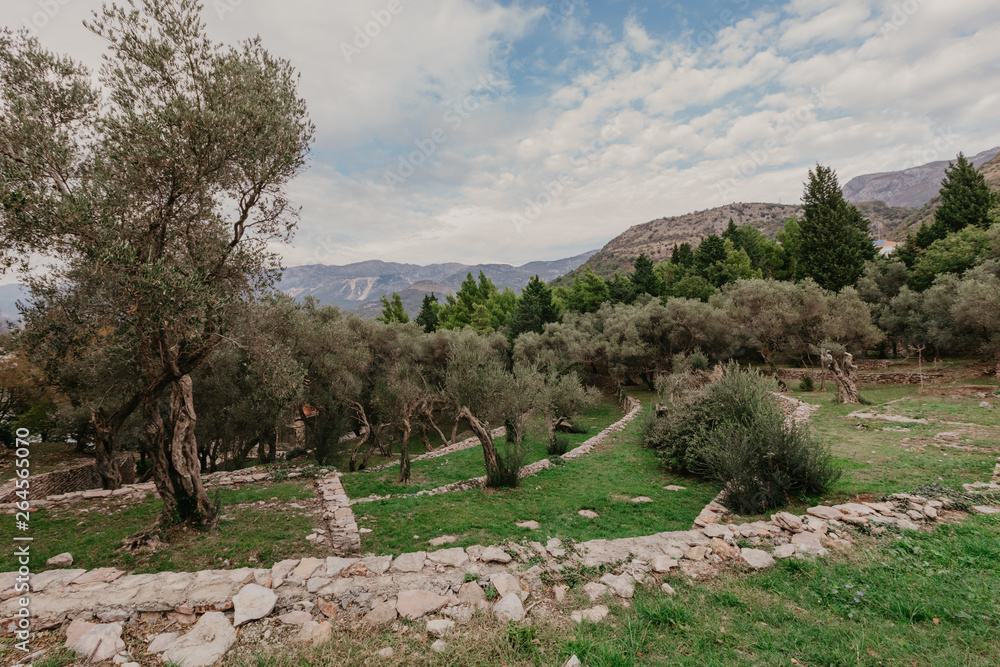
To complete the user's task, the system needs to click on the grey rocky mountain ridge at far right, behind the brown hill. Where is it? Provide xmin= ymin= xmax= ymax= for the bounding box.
xmin=844 ymin=147 xmax=1000 ymax=208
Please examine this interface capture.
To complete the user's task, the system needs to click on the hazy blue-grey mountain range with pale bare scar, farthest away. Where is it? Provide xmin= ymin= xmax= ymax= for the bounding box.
xmin=277 ymin=250 xmax=597 ymax=316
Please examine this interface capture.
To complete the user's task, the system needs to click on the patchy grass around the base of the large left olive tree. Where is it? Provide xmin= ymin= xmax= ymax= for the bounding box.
xmin=0 ymin=482 xmax=325 ymax=573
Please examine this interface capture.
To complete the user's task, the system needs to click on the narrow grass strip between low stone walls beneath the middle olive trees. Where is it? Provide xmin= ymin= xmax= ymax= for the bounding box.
xmin=341 ymin=399 xmax=622 ymax=498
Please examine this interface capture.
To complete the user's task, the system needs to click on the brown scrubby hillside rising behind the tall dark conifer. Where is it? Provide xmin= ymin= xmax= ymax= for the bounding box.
xmin=553 ymin=202 xmax=914 ymax=285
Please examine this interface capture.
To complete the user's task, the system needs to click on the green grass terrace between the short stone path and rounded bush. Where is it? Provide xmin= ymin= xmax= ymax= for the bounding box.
xmin=353 ymin=422 xmax=718 ymax=554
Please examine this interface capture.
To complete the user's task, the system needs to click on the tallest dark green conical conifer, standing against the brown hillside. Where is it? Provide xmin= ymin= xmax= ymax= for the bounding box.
xmin=798 ymin=165 xmax=877 ymax=291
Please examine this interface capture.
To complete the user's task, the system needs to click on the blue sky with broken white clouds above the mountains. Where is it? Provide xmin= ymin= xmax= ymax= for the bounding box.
xmin=0 ymin=0 xmax=1000 ymax=266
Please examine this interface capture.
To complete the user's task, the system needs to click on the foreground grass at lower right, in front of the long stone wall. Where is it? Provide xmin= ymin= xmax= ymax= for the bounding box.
xmin=564 ymin=518 xmax=1000 ymax=667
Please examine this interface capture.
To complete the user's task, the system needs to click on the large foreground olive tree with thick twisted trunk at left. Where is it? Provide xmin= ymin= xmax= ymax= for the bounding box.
xmin=0 ymin=0 xmax=313 ymax=525
